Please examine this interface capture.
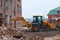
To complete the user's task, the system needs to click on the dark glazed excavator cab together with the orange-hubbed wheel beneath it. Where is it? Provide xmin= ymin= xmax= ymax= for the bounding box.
xmin=32 ymin=16 xmax=43 ymax=31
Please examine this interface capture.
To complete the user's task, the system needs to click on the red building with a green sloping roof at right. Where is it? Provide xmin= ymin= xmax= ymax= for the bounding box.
xmin=48 ymin=7 xmax=60 ymax=24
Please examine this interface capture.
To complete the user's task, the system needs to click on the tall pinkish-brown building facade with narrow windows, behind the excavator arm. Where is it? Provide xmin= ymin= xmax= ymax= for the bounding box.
xmin=0 ymin=0 xmax=22 ymax=27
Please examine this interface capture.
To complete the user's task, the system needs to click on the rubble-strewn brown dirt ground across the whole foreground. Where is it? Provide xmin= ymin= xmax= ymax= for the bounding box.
xmin=0 ymin=28 xmax=60 ymax=40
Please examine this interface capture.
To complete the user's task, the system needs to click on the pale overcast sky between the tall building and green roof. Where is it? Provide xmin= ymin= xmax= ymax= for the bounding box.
xmin=22 ymin=0 xmax=60 ymax=18
